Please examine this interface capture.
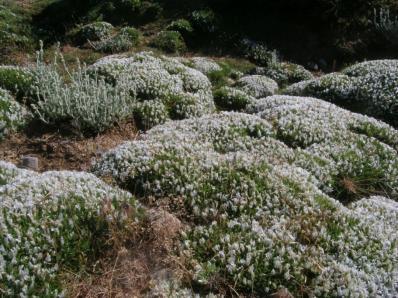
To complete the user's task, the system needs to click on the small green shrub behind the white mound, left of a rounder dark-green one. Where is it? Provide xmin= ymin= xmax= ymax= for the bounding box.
xmin=92 ymin=27 xmax=140 ymax=53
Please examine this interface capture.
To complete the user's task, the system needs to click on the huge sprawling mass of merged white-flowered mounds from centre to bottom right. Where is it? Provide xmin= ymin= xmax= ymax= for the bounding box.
xmin=93 ymin=96 xmax=398 ymax=297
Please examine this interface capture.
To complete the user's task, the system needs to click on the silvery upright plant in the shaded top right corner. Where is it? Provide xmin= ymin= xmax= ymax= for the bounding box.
xmin=373 ymin=8 xmax=398 ymax=47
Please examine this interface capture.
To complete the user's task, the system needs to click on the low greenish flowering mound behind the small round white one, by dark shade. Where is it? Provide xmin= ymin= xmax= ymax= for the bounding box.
xmin=255 ymin=62 xmax=314 ymax=87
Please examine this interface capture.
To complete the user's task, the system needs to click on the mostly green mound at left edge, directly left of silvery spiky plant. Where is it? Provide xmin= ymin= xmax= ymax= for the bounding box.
xmin=0 ymin=65 xmax=34 ymax=100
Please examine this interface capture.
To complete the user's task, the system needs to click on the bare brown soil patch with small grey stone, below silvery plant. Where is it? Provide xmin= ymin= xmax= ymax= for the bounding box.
xmin=0 ymin=122 xmax=139 ymax=171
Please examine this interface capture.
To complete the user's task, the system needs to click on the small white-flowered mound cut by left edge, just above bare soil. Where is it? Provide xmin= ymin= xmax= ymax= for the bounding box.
xmin=0 ymin=89 xmax=29 ymax=140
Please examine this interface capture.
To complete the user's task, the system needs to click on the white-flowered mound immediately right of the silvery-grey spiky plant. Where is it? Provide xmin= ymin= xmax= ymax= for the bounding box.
xmin=90 ymin=52 xmax=215 ymax=128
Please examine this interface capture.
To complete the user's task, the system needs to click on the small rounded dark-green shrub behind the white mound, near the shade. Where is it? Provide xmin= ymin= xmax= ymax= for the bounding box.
xmin=152 ymin=31 xmax=186 ymax=53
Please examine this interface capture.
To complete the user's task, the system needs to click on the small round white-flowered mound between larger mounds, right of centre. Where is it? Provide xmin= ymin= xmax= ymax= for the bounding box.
xmin=235 ymin=75 xmax=278 ymax=98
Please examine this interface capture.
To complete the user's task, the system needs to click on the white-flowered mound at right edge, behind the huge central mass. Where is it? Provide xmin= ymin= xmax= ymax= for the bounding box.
xmin=286 ymin=60 xmax=398 ymax=126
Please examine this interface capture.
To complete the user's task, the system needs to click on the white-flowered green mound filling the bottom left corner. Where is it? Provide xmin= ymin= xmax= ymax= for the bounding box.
xmin=0 ymin=162 xmax=139 ymax=297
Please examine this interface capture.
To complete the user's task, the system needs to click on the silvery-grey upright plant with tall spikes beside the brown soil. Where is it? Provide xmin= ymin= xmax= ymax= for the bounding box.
xmin=32 ymin=41 xmax=134 ymax=133
